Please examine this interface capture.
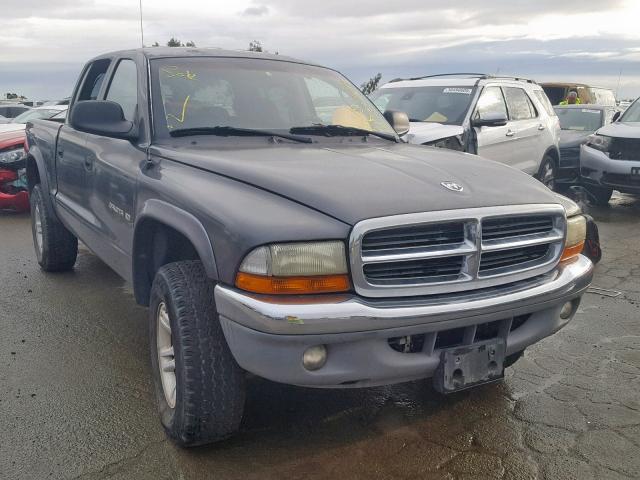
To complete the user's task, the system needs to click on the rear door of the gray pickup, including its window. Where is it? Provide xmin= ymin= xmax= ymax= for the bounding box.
xmin=55 ymin=59 xmax=111 ymax=232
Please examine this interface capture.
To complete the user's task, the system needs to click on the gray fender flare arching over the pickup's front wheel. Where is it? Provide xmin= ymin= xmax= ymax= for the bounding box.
xmin=133 ymin=199 xmax=218 ymax=280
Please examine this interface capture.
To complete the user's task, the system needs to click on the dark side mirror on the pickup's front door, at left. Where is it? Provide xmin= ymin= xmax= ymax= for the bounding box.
xmin=69 ymin=100 xmax=136 ymax=140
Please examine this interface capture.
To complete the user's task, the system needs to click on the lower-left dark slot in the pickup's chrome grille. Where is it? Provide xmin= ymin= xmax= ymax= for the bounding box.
xmin=364 ymin=255 xmax=464 ymax=283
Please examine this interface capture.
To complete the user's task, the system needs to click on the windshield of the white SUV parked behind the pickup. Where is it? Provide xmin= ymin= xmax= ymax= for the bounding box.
xmin=371 ymin=86 xmax=474 ymax=125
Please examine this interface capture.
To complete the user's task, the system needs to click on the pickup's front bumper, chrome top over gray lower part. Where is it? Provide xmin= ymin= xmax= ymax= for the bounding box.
xmin=215 ymin=256 xmax=593 ymax=388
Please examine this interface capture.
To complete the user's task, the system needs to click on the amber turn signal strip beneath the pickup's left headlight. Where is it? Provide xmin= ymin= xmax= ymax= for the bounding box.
xmin=236 ymin=272 xmax=351 ymax=295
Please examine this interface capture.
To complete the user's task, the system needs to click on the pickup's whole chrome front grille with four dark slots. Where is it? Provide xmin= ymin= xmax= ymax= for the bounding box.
xmin=349 ymin=204 xmax=566 ymax=297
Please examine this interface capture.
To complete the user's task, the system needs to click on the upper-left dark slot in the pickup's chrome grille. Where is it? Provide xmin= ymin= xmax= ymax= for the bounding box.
xmin=362 ymin=222 xmax=464 ymax=254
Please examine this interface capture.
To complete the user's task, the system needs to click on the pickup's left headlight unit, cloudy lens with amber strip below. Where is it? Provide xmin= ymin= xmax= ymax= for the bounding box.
xmin=236 ymin=241 xmax=350 ymax=294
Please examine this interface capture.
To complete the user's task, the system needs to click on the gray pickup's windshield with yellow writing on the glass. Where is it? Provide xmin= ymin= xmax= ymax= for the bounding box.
xmin=151 ymin=57 xmax=395 ymax=138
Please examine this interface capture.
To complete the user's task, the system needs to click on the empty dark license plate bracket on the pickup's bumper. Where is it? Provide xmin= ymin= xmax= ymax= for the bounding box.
xmin=433 ymin=338 xmax=506 ymax=393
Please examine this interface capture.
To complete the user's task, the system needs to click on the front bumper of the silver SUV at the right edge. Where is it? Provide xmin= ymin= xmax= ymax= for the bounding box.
xmin=580 ymin=145 xmax=640 ymax=193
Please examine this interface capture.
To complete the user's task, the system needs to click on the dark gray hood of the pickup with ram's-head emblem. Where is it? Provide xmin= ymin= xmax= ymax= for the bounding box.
xmin=151 ymin=139 xmax=558 ymax=225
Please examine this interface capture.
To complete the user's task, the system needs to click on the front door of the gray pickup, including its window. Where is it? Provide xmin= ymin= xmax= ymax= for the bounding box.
xmin=87 ymin=58 xmax=146 ymax=278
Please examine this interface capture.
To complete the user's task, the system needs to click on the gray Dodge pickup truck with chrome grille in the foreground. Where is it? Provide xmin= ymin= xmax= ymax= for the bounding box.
xmin=27 ymin=48 xmax=593 ymax=446
